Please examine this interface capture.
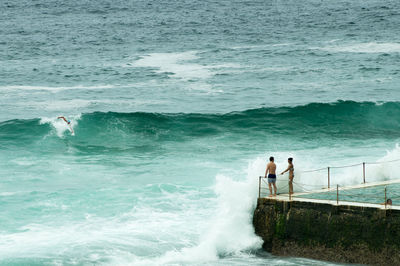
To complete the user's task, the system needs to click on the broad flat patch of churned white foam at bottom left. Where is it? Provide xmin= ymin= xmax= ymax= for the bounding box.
xmin=0 ymin=191 xmax=214 ymax=265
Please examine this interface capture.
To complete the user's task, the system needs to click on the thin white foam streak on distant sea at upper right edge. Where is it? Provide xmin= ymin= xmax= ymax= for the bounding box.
xmin=316 ymin=42 xmax=400 ymax=53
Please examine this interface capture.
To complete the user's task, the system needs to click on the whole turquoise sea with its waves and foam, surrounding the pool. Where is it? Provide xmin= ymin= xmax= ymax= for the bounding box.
xmin=0 ymin=0 xmax=400 ymax=265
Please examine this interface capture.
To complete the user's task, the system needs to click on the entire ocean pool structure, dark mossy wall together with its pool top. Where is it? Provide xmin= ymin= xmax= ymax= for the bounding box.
xmin=253 ymin=169 xmax=400 ymax=265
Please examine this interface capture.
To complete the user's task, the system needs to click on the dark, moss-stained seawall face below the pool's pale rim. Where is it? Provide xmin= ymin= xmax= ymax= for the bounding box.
xmin=253 ymin=198 xmax=400 ymax=265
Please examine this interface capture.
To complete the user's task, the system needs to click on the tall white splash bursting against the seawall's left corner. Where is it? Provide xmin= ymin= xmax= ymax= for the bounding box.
xmin=133 ymin=158 xmax=265 ymax=265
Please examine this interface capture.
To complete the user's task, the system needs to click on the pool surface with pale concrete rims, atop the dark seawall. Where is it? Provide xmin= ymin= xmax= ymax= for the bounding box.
xmin=260 ymin=179 xmax=400 ymax=210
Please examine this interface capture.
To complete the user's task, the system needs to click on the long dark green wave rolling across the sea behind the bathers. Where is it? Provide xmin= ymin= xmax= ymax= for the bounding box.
xmin=0 ymin=101 xmax=400 ymax=147
